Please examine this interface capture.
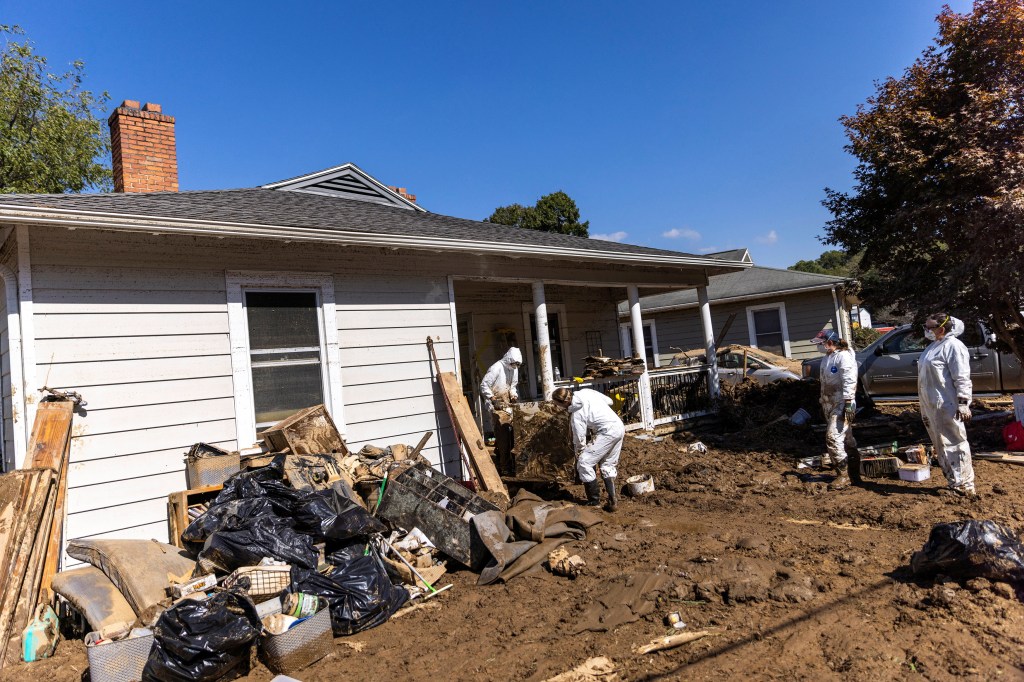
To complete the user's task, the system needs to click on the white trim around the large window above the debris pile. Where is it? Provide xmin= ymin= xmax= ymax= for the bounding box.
xmin=224 ymin=270 xmax=345 ymax=447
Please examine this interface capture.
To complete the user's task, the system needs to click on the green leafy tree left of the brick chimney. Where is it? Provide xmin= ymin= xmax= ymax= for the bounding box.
xmin=0 ymin=25 xmax=111 ymax=194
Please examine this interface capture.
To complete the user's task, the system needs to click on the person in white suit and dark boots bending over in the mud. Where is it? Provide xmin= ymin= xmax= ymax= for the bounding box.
xmin=551 ymin=388 xmax=626 ymax=512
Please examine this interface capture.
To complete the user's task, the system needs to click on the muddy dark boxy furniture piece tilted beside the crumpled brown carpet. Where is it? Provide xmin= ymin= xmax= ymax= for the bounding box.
xmin=376 ymin=464 xmax=498 ymax=567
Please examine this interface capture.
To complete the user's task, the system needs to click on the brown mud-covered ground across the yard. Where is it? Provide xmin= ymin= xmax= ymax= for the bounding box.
xmin=8 ymin=409 xmax=1024 ymax=682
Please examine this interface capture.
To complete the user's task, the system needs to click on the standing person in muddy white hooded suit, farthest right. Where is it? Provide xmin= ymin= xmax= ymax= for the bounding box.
xmin=918 ymin=312 xmax=977 ymax=498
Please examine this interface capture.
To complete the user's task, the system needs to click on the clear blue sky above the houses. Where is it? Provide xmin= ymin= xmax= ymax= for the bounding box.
xmin=0 ymin=0 xmax=970 ymax=267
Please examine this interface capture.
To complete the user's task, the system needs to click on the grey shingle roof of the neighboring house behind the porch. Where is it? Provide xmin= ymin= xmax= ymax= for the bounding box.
xmin=618 ymin=262 xmax=848 ymax=314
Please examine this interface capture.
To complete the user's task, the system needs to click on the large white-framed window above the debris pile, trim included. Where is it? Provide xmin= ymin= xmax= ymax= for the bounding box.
xmin=226 ymin=272 xmax=344 ymax=447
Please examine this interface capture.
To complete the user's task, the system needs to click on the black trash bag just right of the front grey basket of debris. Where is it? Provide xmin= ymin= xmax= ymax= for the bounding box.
xmin=290 ymin=552 xmax=409 ymax=637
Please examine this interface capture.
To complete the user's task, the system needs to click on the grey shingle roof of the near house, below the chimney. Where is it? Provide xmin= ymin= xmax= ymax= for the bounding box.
xmin=0 ymin=188 xmax=729 ymax=258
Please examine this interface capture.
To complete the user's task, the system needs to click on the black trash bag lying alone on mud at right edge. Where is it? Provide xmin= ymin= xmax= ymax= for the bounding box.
xmin=910 ymin=520 xmax=1024 ymax=583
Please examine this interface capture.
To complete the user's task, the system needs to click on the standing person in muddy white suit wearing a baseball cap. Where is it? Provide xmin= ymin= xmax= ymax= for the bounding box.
xmin=811 ymin=329 xmax=860 ymax=491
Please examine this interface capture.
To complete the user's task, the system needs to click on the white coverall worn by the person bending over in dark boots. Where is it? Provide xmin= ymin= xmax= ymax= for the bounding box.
xmin=568 ymin=388 xmax=626 ymax=483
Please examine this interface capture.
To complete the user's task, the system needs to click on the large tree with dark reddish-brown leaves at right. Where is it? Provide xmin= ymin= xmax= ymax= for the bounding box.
xmin=823 ymin=0 xmax=1024 ymax=358
